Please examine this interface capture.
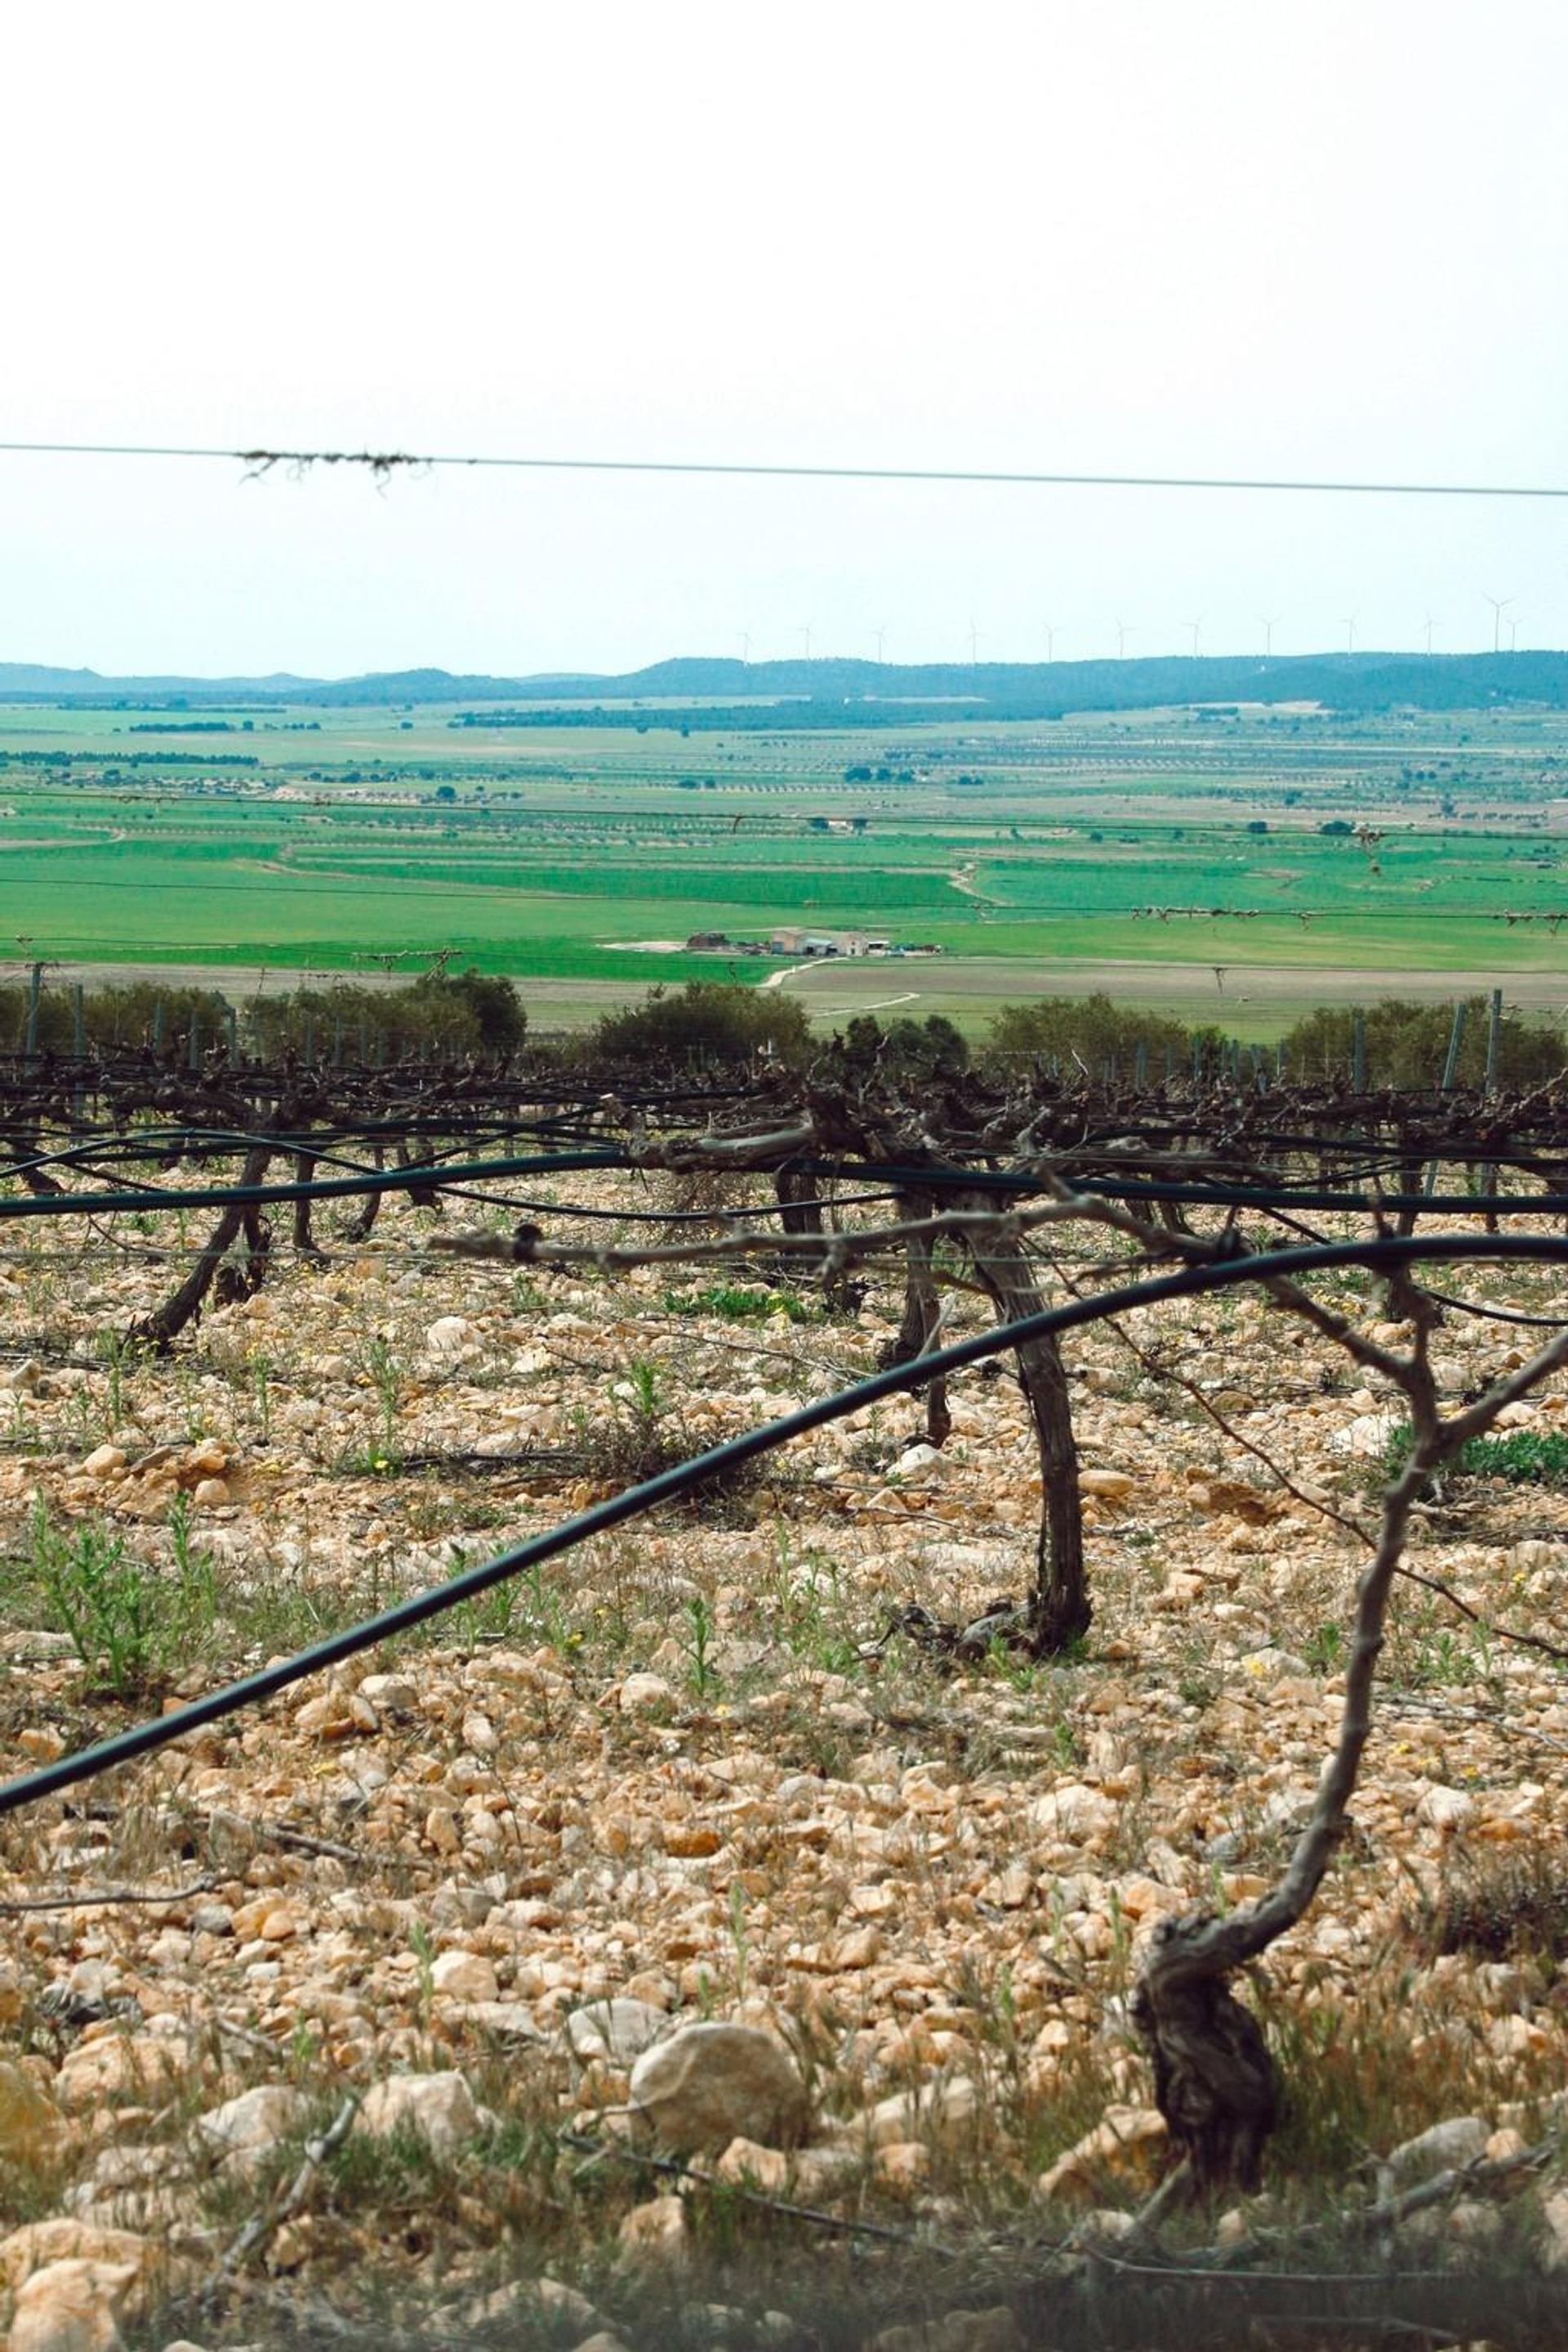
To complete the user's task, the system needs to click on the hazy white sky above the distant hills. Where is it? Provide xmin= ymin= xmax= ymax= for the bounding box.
xmin=0 ymin=0 xmax=1568 ymax=673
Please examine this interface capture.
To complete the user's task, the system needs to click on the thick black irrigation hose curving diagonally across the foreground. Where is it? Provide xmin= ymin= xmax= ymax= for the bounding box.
xmin=0 ymin=1232 xmax=1568 ymax=1815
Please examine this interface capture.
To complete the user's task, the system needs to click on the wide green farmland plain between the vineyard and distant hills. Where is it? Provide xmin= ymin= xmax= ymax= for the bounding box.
xmin=0 ymin=706 xmax=1568 ymax=1026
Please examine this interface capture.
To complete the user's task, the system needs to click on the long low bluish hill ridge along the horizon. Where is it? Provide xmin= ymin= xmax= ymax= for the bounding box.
xmin=0 ymin=654 xmax=1568 ymax=724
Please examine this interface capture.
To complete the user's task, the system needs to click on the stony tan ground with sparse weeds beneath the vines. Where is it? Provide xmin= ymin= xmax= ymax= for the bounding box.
xmin=0 ymin=1178 xmax=1568 ymax=2352
